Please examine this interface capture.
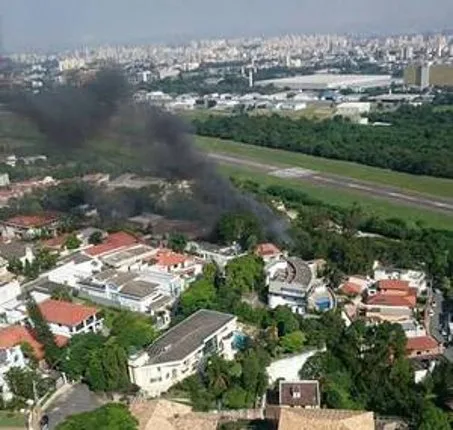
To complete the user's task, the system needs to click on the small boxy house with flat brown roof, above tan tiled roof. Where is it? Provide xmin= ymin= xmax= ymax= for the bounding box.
xmin=278 ymin=380 xmax=321 ymax=408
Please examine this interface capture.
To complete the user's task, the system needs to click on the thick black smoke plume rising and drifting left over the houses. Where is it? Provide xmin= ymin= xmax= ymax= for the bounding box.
xmin=1 ymin=70 xmax=288 ymax=241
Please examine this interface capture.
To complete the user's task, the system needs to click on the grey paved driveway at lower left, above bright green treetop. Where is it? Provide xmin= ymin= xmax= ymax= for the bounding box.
xmin=46 ymin=384 xmax=103 ymax=430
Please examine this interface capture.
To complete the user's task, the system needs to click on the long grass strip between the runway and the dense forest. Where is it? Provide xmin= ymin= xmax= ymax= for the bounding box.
xmin=196 ymin=136 xmax=453 ymax=198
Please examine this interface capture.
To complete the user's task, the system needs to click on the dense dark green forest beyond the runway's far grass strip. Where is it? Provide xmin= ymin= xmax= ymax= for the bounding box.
xmin=193 ymin=106 xmax=453 ymax=178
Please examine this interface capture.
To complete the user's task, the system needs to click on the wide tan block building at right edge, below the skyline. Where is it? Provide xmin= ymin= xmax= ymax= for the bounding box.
xmin=404 ymin=64 xmax=453 ymax=88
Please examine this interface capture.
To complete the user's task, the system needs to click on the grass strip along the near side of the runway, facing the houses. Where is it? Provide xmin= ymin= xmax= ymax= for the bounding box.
xmin=219 ymin=166 xmax=453 ymax=231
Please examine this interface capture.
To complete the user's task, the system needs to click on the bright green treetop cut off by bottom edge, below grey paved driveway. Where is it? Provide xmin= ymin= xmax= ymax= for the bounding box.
xmin=56 ymin=403 xmax=138 ymax=430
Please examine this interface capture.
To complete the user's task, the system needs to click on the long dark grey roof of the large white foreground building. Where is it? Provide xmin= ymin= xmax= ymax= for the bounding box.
xmin=143 ymin=309 xmax=236 ymax=364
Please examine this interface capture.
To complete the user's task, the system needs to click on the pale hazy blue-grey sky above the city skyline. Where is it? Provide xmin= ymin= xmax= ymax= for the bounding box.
xmin=0 ymin=0 xmax=453 ymax=50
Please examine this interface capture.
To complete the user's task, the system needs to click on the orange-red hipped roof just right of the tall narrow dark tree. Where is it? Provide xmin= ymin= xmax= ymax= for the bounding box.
xmin=39 ymin=299 xmax=98 ymax=327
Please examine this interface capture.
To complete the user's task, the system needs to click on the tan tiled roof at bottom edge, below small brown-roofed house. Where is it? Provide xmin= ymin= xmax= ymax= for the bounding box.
xmin=272 ymin=408 xmax=375 ymax=430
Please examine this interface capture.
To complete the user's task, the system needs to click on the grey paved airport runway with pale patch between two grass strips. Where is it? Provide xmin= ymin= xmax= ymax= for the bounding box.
xmin=208 ymin=153 xmax=453 ymax=216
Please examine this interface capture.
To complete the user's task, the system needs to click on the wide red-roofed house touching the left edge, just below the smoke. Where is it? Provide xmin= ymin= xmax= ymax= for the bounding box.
xmin=0 ymin=213 xmax=60 ymax=239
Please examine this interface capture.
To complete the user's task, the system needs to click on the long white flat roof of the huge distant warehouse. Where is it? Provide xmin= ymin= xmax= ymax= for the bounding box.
xmin=256 ymin=73 xmax=392 ymax=90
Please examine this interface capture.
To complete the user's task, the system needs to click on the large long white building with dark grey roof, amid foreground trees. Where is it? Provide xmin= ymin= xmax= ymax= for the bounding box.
xmin=129 ymin=309 xmax=237 ymax=397
